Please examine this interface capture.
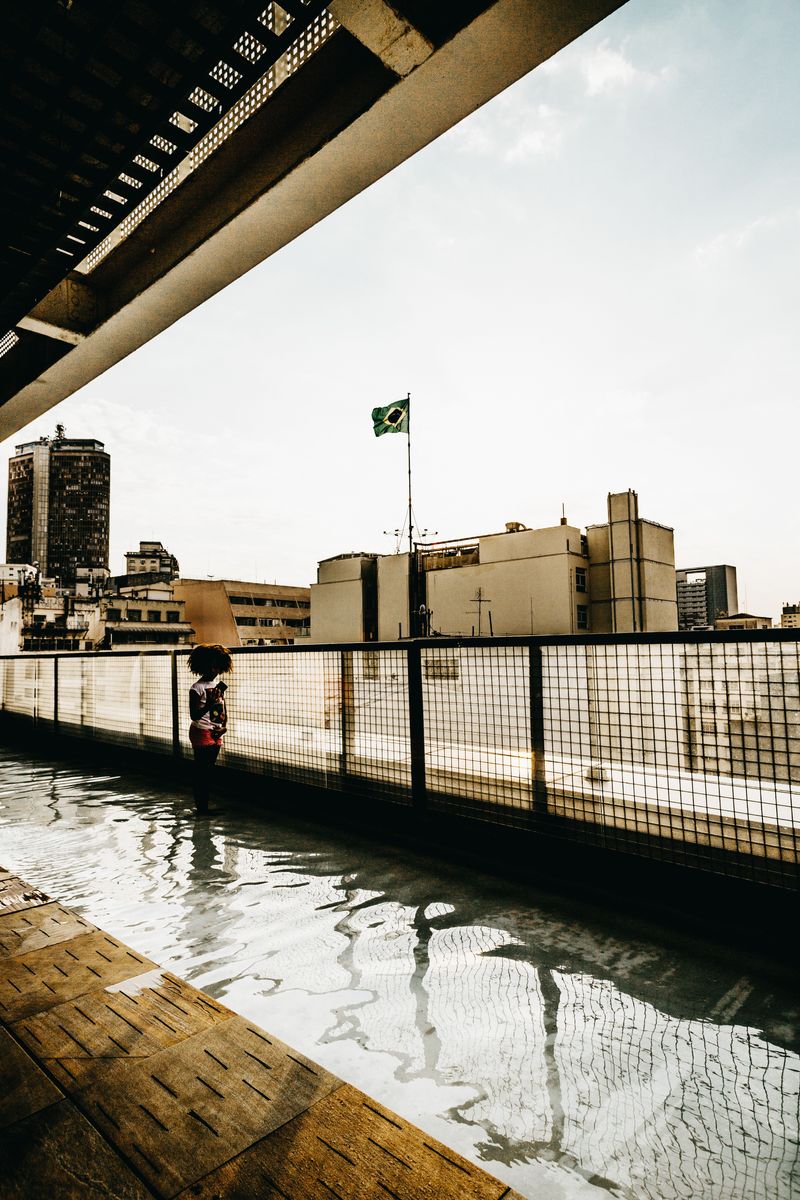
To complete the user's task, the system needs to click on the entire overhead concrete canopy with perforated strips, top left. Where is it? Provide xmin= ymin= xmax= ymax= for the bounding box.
xmin=0 ymin=0 xmax=624 ymax=438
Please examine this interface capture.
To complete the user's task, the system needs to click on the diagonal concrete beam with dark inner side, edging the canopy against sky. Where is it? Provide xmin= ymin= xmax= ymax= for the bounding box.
xmin=0 ymin=0 xmax=625 ymax=438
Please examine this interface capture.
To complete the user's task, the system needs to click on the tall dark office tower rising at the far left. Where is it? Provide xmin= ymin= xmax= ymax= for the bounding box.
xmin=6 ymin=426 xmax=112 ymax=587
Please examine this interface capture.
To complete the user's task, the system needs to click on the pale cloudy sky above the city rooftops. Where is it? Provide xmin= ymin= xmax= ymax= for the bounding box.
xmin=0 ymin=0 xmax=800 ymax=617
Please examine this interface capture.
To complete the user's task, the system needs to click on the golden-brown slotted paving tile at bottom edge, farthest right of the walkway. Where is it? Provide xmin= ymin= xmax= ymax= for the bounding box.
xmin=173 ymin=1084 xmax=521 ymax=1200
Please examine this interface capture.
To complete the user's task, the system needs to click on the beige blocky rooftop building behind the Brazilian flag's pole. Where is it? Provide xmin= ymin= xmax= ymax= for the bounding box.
xmin=311 ymin=492 xmax=676 ymax=642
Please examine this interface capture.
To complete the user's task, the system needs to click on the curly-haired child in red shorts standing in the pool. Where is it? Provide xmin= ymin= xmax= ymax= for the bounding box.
xmin=188 ymin=643 xmax=234 ymax=816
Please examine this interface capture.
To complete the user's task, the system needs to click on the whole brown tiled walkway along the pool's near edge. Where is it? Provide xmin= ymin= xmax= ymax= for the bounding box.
xmin=0 ymin=869 xmax=522 ymax=1200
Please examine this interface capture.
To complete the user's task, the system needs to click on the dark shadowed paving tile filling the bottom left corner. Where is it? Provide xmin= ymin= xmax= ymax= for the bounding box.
xmin=0 ymin=1100 xmax=152 ymax=1200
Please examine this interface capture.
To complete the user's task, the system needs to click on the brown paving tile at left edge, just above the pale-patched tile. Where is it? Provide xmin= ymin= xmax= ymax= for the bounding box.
xmin=0 ymin=932 xmax=155 ymax=1024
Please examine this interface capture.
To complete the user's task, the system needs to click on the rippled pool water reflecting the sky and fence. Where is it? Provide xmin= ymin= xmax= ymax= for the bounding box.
xmin=0 ymin=751 xmax=800 ymax=1200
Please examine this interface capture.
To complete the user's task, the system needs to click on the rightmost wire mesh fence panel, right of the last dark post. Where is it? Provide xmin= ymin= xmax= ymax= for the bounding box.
xmin=542 ymin=642 xmax=800 ymax=882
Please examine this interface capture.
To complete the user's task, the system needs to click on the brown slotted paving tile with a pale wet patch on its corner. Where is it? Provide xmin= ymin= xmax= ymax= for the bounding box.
xmin=12 ymin=968 xmax=234 ymax=1092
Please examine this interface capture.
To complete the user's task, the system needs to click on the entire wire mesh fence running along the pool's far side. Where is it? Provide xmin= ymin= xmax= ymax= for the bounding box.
xmin=0 ymin=631 xmax=800 ymax=887
